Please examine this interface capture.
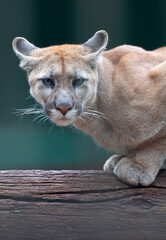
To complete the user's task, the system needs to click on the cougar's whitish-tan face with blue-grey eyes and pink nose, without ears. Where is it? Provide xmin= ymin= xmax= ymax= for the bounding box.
xmin=29 ymin=47 xmax=97 ymax=126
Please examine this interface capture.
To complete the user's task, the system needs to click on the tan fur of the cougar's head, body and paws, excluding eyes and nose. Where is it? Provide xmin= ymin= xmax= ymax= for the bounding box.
xmin=14 ymin=31 xmax=166 ymax=186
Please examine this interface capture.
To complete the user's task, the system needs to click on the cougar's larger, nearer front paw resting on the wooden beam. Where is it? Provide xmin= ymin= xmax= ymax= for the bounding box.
xmin=114 ymin=158 xmax=155 ymax=186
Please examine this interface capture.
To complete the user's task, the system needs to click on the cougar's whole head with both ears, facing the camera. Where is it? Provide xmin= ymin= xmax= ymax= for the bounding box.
xmin=13 ymin=31 xmax=108 ymax=126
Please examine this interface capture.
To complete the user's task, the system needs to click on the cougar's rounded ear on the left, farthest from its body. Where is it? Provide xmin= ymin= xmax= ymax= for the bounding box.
xmin=12 ymin=37 xmax=38 ymax=70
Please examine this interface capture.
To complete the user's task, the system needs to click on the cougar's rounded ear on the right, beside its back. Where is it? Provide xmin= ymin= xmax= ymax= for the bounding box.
xmin=83 ymin=30 xmax=108 ymax=66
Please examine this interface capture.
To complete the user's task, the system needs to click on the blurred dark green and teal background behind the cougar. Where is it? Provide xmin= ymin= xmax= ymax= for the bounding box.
xmin=0 ymin=0 xmax=166 ymax=169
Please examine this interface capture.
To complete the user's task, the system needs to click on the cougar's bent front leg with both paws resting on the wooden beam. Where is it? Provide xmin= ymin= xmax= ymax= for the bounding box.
xmin=104 ymin=139 xmax=166 ymax=186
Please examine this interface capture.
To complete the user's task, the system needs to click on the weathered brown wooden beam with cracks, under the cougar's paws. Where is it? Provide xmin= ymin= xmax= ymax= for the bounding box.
xmin=0 ymin=170 xmax=166 ymax=240
